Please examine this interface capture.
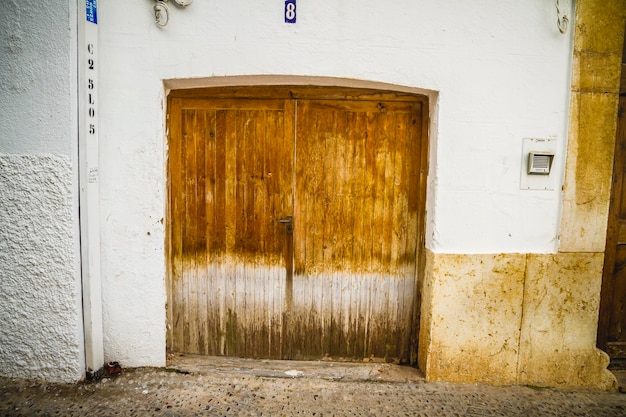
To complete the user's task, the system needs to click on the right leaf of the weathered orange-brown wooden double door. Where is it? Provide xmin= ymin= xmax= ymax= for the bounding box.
xmin=291 ymin=100 xmax=422 ymax=361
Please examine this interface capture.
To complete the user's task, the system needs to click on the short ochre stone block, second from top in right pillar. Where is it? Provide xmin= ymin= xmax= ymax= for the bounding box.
xmin=572 ymin=51 xmax=622 ymax=94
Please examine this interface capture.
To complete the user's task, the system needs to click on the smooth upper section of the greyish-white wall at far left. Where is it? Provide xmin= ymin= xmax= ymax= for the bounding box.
xmin=0 ymin=0 xmax=76 ymax=155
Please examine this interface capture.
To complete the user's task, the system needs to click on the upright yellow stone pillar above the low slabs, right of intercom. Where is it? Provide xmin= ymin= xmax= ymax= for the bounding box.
xmin=559 ymin=0 xmax=626 ymax=253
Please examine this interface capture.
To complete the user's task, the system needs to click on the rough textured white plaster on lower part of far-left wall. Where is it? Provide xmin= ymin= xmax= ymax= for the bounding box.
xmin=0 ymin=154 xmax=84 ymax=381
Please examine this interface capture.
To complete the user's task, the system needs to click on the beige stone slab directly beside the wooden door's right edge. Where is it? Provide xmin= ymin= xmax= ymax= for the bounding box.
xmin=420 ymin=250 xmax=526 ymax=385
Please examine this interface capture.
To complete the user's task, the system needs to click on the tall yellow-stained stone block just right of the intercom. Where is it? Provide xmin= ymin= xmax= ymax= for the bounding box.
xmin=559 ymin=93 xmax=618 ymax=252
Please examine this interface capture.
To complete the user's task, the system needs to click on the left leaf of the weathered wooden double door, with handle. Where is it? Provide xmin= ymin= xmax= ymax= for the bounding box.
xmin=168 ymin=99 xmax=294 ymax=357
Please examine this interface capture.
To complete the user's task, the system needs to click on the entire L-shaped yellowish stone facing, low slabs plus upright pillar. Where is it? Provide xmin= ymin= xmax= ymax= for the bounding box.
xmin=418 ymin=0 xmax=626 ymax=389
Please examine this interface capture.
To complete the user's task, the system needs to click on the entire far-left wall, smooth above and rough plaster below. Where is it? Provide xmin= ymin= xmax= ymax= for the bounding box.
xmin=0 ymin=0 xmax=84 ymax=381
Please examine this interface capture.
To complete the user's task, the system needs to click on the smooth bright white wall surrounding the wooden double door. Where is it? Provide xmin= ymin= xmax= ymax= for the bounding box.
xmin=99 ymin=0 xmax=573 ymax=365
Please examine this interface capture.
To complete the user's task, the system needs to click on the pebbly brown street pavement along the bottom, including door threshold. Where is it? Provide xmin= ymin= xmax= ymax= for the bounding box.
xmin=0 ymin=358 xmax=626 ymax=417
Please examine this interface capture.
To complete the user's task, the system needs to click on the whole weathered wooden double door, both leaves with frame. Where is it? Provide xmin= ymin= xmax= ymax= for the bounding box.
xmin=167 ymin=87 xmax=427 ymax=363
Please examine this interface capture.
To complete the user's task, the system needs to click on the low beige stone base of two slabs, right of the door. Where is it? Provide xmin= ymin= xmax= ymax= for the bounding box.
xmin=419 ymin=252 xmax=615 ymax=389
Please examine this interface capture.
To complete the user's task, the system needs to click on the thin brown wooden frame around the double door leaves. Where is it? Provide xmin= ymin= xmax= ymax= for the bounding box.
xmin=165 ymin=85 xmax=430 ymax=365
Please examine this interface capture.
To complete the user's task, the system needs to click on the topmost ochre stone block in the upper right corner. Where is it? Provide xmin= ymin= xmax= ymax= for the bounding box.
xmin=574 ymin=0 xmax=626 ymax=54
